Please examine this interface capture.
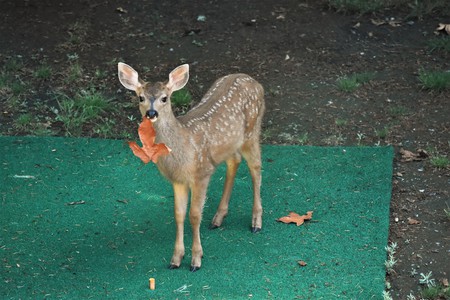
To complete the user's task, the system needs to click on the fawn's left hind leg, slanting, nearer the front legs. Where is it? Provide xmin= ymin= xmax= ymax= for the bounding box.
xmin=210 ymin=153 xmax=242 ymax=229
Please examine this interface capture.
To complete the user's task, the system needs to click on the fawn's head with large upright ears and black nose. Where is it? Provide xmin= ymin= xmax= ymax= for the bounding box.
xmin=117 ymin=63 xmax=189 ymax=122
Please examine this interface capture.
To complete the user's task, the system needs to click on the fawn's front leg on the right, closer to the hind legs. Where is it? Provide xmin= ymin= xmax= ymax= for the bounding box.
xmin=189 ymin=177 xmax=209 ymax=272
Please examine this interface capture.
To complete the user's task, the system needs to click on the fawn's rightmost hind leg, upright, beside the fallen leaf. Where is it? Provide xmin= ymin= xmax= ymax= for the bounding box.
xmin=241 ymin=139 xmax=263 ymax=232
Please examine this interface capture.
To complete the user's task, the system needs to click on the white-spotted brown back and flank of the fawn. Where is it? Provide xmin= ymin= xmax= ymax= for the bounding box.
xmin=179 ymin=74 xmax=265 ymax=164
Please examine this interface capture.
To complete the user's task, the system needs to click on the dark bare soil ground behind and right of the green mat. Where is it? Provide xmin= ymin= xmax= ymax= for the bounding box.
xmin=0 ymin=0 xmax=450 ymax=299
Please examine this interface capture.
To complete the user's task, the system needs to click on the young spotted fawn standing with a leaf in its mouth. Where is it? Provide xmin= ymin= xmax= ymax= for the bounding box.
xmin=118 ymin=63 xmax=265 ymax=272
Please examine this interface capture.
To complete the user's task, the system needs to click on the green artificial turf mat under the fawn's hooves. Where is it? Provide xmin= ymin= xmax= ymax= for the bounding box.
xmin=0 ymin=137 xmax=393 ymax=299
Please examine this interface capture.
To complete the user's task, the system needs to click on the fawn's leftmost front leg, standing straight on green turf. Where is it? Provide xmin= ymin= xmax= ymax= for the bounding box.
xmin=169 ymin=183 xmax=189 ymax=269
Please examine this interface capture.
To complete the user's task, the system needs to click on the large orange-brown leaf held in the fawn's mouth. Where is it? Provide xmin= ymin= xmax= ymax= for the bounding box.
xmin=128 ymin=117 xmax=172 ymax=164
